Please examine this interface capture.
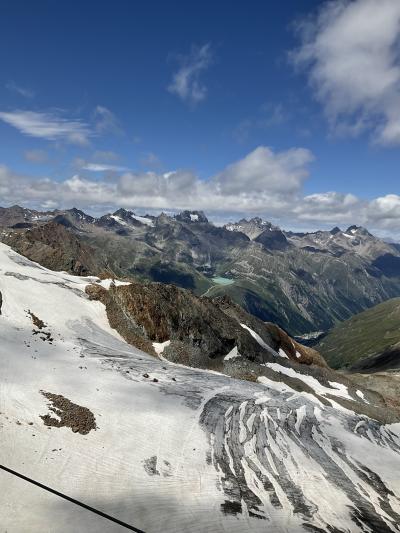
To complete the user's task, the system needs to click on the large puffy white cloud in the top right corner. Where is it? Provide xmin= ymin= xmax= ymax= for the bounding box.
xmin=291 ymin=0 xmax=400 ymax=145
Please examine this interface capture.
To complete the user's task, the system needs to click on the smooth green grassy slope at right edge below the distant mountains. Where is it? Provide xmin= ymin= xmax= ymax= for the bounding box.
xmin=316 ymin=298 xmax=400 ymax=372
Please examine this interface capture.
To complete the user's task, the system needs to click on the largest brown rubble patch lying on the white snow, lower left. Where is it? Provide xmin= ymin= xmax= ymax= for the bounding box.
xmin=40 ymin=391 xmax=97 ymax=435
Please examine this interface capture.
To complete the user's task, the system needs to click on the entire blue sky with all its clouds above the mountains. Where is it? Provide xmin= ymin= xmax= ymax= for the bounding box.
xmin=0 ymin=0 xmax=400 ymax=239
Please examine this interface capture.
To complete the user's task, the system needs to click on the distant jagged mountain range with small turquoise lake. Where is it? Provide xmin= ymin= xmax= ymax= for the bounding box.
xmin=0 ymin=203 xmax=400 ymax=335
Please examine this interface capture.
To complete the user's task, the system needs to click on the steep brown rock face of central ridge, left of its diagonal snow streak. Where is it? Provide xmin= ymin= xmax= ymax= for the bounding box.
xmin=88 ymin=282 xmax=269 ymax=366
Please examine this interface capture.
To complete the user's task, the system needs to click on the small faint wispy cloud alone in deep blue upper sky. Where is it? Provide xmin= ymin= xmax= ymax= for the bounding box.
xmin=168 ymin=43 xmax=213 ymax=105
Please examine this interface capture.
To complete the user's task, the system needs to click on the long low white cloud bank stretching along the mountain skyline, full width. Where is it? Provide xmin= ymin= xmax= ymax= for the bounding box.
xmin=0 ymin=146 xmax=400 ymax=238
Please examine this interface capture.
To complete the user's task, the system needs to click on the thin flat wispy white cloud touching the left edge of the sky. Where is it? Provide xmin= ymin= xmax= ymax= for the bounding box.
xmin=0 ymin=110 xmax=93 ymax=145
